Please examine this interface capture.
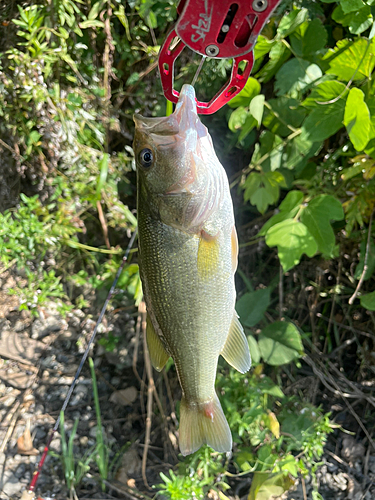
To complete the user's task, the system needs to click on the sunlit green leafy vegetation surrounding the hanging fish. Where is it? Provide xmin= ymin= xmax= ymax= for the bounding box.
xmin=0 ymin=0 xmax=375 ymax=500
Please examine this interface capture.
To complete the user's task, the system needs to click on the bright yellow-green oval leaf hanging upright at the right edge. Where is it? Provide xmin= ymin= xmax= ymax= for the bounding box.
xmin=344 ymin=88 xmax=371 ymax=151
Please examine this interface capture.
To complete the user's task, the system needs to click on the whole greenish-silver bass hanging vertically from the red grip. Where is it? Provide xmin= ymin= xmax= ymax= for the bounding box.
xmin=133 ymin=85 xmax=251 ymax=456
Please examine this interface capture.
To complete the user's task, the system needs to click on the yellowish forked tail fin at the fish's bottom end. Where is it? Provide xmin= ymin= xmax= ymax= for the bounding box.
xmin=179 ymin=394 xmax=232 ymax=456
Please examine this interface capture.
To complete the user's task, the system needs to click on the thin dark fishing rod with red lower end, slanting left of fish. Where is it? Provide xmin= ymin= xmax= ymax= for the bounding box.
xmin=21 ymin=229 xmax=137 ymax=500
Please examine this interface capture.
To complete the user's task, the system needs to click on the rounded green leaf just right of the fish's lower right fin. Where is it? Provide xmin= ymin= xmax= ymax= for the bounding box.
xmin=258 ymin=321 xmax=303 ymax=366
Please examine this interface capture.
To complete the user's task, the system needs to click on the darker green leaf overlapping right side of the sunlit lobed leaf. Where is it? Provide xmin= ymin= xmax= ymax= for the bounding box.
xmin=301 ymin=194 xmax=344 ymax=257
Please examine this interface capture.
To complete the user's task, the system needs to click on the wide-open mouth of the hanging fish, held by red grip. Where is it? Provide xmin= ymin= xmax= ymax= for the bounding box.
xmin=134 ymin=84 xmax=200 ymax=136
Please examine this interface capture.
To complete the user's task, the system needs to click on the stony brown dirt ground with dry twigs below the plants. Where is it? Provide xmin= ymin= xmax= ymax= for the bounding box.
xmin=0 ymin=273 xmax=375 ymax=500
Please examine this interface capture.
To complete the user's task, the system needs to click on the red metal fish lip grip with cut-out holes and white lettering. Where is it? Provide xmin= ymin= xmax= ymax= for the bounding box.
xmin=159 ymin=0 xmax=281 ymax=115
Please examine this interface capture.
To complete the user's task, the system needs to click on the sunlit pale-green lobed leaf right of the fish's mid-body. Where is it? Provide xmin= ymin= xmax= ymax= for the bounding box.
xmin=266 ymin=219 xmax=318 ymax=272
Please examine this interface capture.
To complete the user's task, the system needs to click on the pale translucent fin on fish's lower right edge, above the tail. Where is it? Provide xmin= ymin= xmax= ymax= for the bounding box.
xmin=221 ymin=312 xmax=251 ymax=373
